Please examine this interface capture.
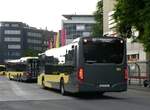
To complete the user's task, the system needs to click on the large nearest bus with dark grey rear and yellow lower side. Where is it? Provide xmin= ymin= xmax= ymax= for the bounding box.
xmin=38 ymin=37 xmax=128 ymax=95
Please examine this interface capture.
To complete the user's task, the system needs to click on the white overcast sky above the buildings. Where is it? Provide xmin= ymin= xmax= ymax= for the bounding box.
xmin=0 ymin=0 xmax=98 ymax=31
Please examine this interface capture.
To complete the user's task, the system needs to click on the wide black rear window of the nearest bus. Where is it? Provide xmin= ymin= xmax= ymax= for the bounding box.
xmin=83 ymin=39 xmax=124 ymax=64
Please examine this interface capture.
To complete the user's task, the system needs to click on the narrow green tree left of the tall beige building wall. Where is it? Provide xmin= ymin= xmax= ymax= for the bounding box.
xmin=92 ymin=0 xmax=103 ymax=37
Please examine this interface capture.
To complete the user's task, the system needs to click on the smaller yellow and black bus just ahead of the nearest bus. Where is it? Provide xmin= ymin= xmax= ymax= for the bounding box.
xmin=6 ymin=57 xmax=39 ymax=81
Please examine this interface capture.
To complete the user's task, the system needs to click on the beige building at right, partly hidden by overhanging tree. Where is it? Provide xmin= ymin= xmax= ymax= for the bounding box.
xmin=103 ymin=0 xmax=150 ymax=84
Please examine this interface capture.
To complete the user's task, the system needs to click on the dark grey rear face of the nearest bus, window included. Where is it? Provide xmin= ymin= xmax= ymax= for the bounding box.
xmin=78 ymin=39 xmax=126 ymax=88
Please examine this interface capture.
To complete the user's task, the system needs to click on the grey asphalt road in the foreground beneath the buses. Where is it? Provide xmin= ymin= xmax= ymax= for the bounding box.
xmin=0 ymin=76 xmax=150 ymax=110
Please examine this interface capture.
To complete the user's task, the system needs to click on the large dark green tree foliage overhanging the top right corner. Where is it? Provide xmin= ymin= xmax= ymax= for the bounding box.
xmin=114 ymin=0 xmax=150 ymax=52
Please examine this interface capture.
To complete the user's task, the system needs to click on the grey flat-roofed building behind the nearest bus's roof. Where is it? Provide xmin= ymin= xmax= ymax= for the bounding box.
xmin=62 ymin=15 xmax=96 ymax=44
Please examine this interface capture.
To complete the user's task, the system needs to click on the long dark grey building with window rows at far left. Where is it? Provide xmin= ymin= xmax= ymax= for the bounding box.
xmin=0 ymin=22 xmax=50 ymax=63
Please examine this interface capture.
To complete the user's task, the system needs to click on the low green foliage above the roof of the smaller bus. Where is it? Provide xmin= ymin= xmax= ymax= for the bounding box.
xmin=22 ymin=49 xmax=40 ymax=57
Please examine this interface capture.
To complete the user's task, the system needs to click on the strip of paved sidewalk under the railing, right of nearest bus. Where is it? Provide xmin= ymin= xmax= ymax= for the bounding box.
xmin=128 ymin=84 xmax=150 ymax=92
